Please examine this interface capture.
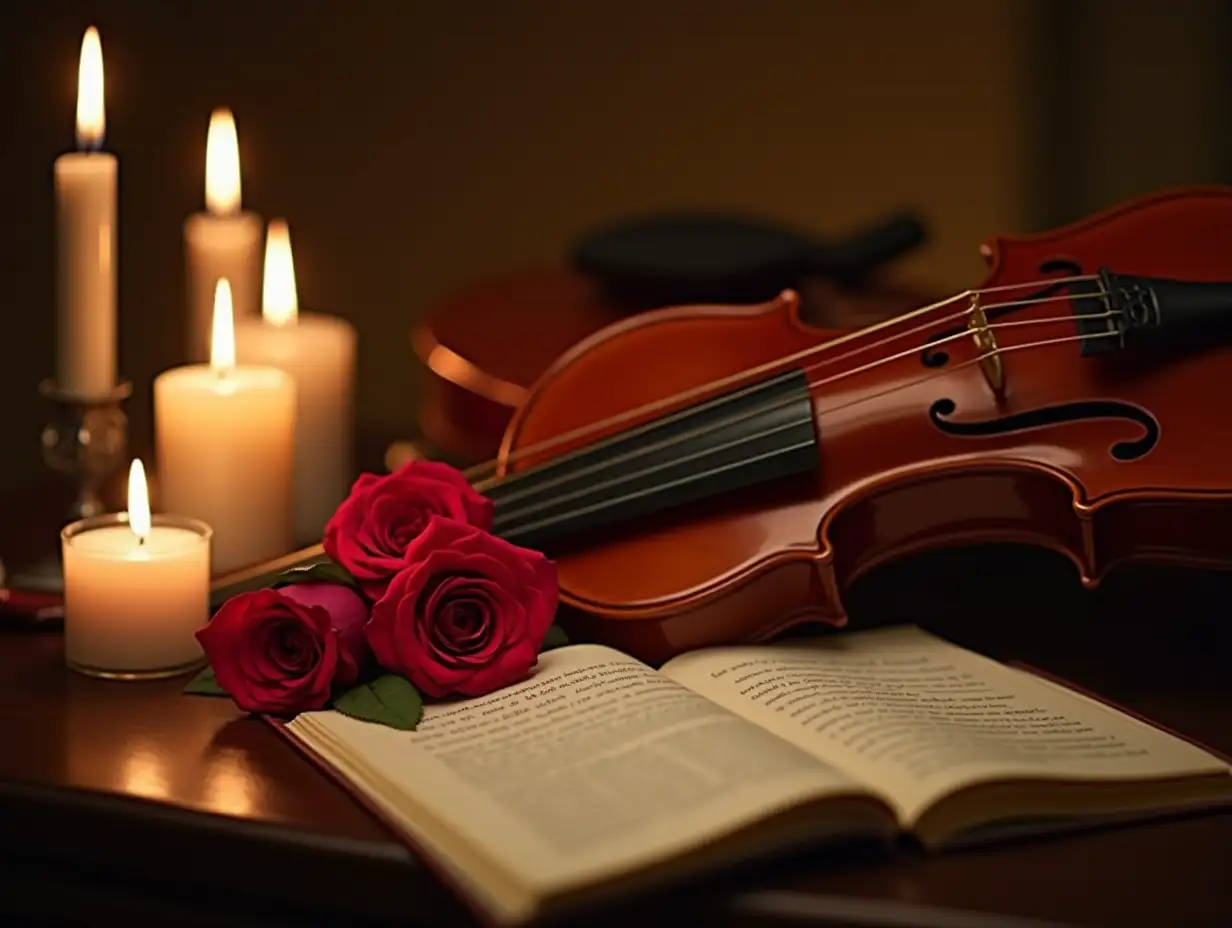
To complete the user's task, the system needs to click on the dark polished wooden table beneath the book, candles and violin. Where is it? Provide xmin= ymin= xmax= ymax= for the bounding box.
xmin=0 ymin=532 xmax=1232 ymax=928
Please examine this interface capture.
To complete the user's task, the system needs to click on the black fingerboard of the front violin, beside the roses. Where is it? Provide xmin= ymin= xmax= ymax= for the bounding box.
xmin=487 ymin=368 xmax=818 ymax=548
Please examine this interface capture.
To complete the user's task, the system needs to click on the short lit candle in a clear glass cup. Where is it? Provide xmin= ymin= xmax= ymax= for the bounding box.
xmin=60 ymin=460 xmax=211 ymax=679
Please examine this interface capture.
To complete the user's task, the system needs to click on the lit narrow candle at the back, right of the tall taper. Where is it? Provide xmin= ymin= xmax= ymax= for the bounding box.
xmin=184 ymin=108 xmax=261 ymax=362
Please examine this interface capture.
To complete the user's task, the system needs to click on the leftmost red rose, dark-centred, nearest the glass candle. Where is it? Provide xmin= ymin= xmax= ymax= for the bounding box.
xmin=197 ymin=583 xmax=370 ymax=715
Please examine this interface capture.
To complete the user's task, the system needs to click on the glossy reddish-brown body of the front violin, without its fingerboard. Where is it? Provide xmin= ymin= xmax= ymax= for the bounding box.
xmin=498 ymin=187 xmax=1232 ymax=663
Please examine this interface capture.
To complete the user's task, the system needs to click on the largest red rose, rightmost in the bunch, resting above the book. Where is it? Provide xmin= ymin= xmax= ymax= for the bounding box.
xmin=365 ymin=518 xmax=557 ymax=699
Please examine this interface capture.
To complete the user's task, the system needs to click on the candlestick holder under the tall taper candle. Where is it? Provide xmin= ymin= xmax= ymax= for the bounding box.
xmin=12 ymin=378 xmax=133 ymax=592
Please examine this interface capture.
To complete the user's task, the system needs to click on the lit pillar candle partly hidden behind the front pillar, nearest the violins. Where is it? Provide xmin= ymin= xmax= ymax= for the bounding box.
xmin=235 ymin=219 xmax=356 ymax=545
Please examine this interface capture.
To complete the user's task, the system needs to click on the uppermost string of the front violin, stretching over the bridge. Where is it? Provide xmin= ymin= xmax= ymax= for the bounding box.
xmin=463 ymin=275 xmax=1106 ymax=492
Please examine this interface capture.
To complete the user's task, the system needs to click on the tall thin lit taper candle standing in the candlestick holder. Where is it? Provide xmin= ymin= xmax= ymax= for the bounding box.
xmin=53 ymin=26 xmax=118 ymax=396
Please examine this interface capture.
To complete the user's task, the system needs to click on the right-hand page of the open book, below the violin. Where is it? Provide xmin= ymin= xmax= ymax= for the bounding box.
xmin=662 ymin=627 xmax=1227 ymax=823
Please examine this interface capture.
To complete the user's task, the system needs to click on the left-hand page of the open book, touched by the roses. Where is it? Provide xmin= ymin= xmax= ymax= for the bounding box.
xmin=288 ymin=645 xmax=892 ymax=907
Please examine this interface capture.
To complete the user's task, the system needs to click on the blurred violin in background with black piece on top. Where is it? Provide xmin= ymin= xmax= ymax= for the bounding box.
xmin=410 ymin=212 xmax=933 ymax=462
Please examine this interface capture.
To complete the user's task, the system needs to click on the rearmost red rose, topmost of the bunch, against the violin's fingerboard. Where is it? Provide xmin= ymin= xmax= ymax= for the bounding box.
xmin=324 ymin=461 xmax=493 ymax=599
